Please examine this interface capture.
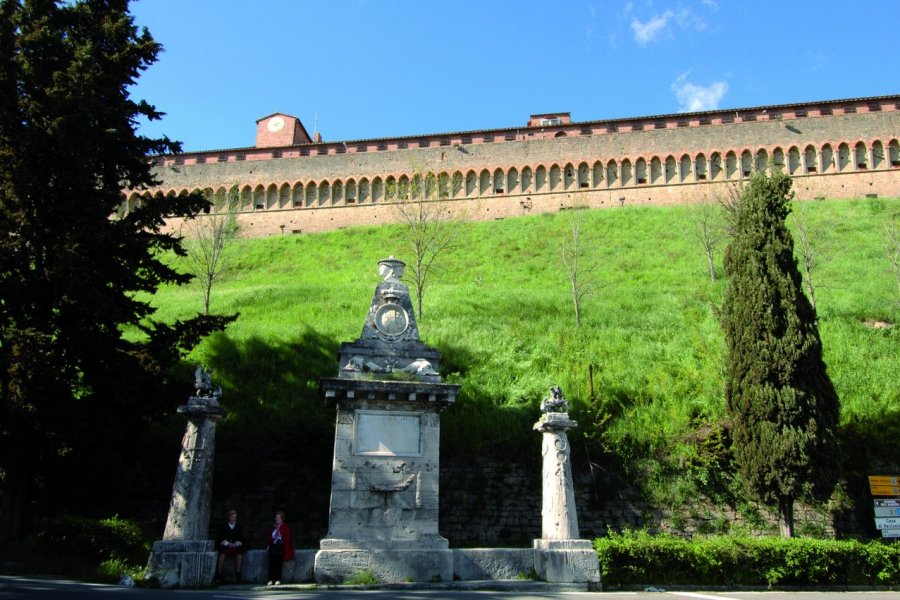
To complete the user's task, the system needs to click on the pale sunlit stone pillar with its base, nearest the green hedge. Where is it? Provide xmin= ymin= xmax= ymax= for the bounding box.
xmin=534 ymin=387 xmax=600 ymax=585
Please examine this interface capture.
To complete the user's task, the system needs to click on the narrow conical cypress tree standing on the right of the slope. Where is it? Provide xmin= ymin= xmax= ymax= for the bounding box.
xmin=721 ymin=174 xmax=840 ymax=536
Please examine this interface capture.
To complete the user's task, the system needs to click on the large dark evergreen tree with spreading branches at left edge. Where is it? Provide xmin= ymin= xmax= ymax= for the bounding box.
xmin=0 ymin=0 xmax=236 ymax=545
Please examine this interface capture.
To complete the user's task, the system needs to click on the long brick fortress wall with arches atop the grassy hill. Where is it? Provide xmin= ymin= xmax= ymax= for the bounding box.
xmin=132 ymin=97 xmax=900 ymax=235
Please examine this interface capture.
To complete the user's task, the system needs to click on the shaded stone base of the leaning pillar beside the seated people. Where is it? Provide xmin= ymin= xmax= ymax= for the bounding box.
xmin=147 ymin=540 xmax=217 ymax=588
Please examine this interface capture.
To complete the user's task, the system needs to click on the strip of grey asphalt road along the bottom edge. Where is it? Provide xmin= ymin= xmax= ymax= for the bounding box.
xmin=0 ymin=577 xmax=900 ymax=600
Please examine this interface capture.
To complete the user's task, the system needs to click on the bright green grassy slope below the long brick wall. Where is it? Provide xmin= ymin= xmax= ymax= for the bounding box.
xmin=153 ymin=199 xmax=900 ymax=520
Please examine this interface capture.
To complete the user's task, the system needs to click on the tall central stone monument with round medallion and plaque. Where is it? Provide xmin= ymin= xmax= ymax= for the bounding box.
xmin=315 ymin=256 xmax=460 ymax=583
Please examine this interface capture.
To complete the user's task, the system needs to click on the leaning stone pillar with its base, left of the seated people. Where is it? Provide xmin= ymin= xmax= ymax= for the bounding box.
xmin=148 ymin=367 xmax=225 ymax=588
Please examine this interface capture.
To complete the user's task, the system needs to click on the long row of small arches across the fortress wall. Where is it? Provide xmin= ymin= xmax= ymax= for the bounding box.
xmin=129 ymin=139 xmax=900 ymax=211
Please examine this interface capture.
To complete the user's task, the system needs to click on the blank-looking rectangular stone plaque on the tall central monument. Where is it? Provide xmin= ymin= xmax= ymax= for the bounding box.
xmin=355 ymin=410 xmax=422 ymax=456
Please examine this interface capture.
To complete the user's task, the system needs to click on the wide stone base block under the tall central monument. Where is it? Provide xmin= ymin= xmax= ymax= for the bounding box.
xmin=315 ymin=548 xmax=453 ymax=583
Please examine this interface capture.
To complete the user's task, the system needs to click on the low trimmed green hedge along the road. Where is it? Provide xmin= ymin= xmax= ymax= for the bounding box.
xmin=594 ymin=532 xmax=900 ymax=589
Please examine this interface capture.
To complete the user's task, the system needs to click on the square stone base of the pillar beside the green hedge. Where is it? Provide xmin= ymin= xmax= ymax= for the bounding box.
xmin=534 ymin=539 xmax=600 ymax=590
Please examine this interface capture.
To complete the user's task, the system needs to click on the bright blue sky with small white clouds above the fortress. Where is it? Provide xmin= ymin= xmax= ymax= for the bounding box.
xmin=132 ymin=0 xmax=900 ymax=151
